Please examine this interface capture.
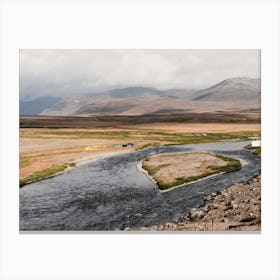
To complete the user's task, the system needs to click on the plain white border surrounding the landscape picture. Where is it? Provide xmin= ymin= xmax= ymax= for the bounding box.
xmin=0 ymin=0 xmax=280 ymax=280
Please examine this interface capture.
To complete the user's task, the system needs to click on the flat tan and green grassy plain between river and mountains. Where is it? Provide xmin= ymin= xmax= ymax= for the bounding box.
xmin=19 ymin=118 xmax=260 ymax=186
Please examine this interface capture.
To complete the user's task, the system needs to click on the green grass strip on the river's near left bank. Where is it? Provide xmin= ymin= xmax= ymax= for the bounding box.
xmin=19 ymin=162 xmax=76 ymax=187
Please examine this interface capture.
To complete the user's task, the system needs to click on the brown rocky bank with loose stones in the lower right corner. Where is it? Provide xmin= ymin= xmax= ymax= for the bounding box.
xmin=133 ymin=174 xmax=261 ymax=231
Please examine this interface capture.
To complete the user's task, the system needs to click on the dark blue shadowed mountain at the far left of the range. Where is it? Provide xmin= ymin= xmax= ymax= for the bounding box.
xmin=19 ymin=96 xmax=61 ymax=115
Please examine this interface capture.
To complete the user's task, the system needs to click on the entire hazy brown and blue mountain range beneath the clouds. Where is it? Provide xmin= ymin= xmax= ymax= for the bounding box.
xmin=20 ymin=77 xmax=261 ymax=116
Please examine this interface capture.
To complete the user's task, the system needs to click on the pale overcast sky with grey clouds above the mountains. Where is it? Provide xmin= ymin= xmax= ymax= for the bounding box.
xmin=19 ymin=49 xmax=260 ymax=99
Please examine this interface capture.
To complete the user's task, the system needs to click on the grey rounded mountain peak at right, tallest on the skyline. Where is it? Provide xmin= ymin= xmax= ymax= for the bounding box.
xmin=193 ymin=77 xmax=261 ymax=105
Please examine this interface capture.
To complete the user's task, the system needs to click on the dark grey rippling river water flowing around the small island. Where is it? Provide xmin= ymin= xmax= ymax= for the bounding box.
xmin=19 ymin=141 xmax=261 ymax=231
